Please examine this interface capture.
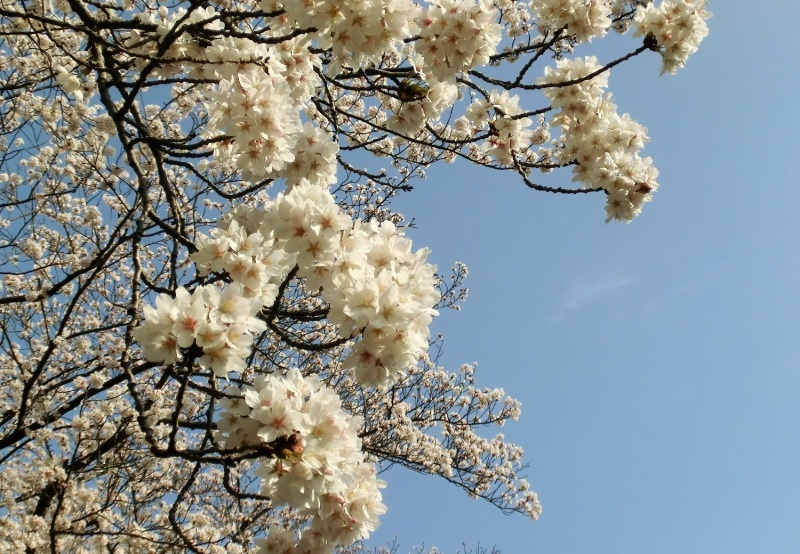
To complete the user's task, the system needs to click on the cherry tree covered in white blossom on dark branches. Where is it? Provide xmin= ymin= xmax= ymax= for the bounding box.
xmin=0 ymin=0 xmax=710 ymax=553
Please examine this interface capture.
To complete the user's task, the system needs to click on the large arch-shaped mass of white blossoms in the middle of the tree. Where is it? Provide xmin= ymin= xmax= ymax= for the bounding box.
xmin=136 ymin=182 xmax=439 ymax=386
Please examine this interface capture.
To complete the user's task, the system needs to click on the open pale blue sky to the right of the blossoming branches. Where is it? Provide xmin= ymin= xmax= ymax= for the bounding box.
xmin=368 ymin=0 xmax=800 ymax=554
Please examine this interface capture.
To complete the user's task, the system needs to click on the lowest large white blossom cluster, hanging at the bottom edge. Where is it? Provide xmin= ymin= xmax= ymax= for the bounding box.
xmin=217 ymin=369 xmax=386 ymax=554
